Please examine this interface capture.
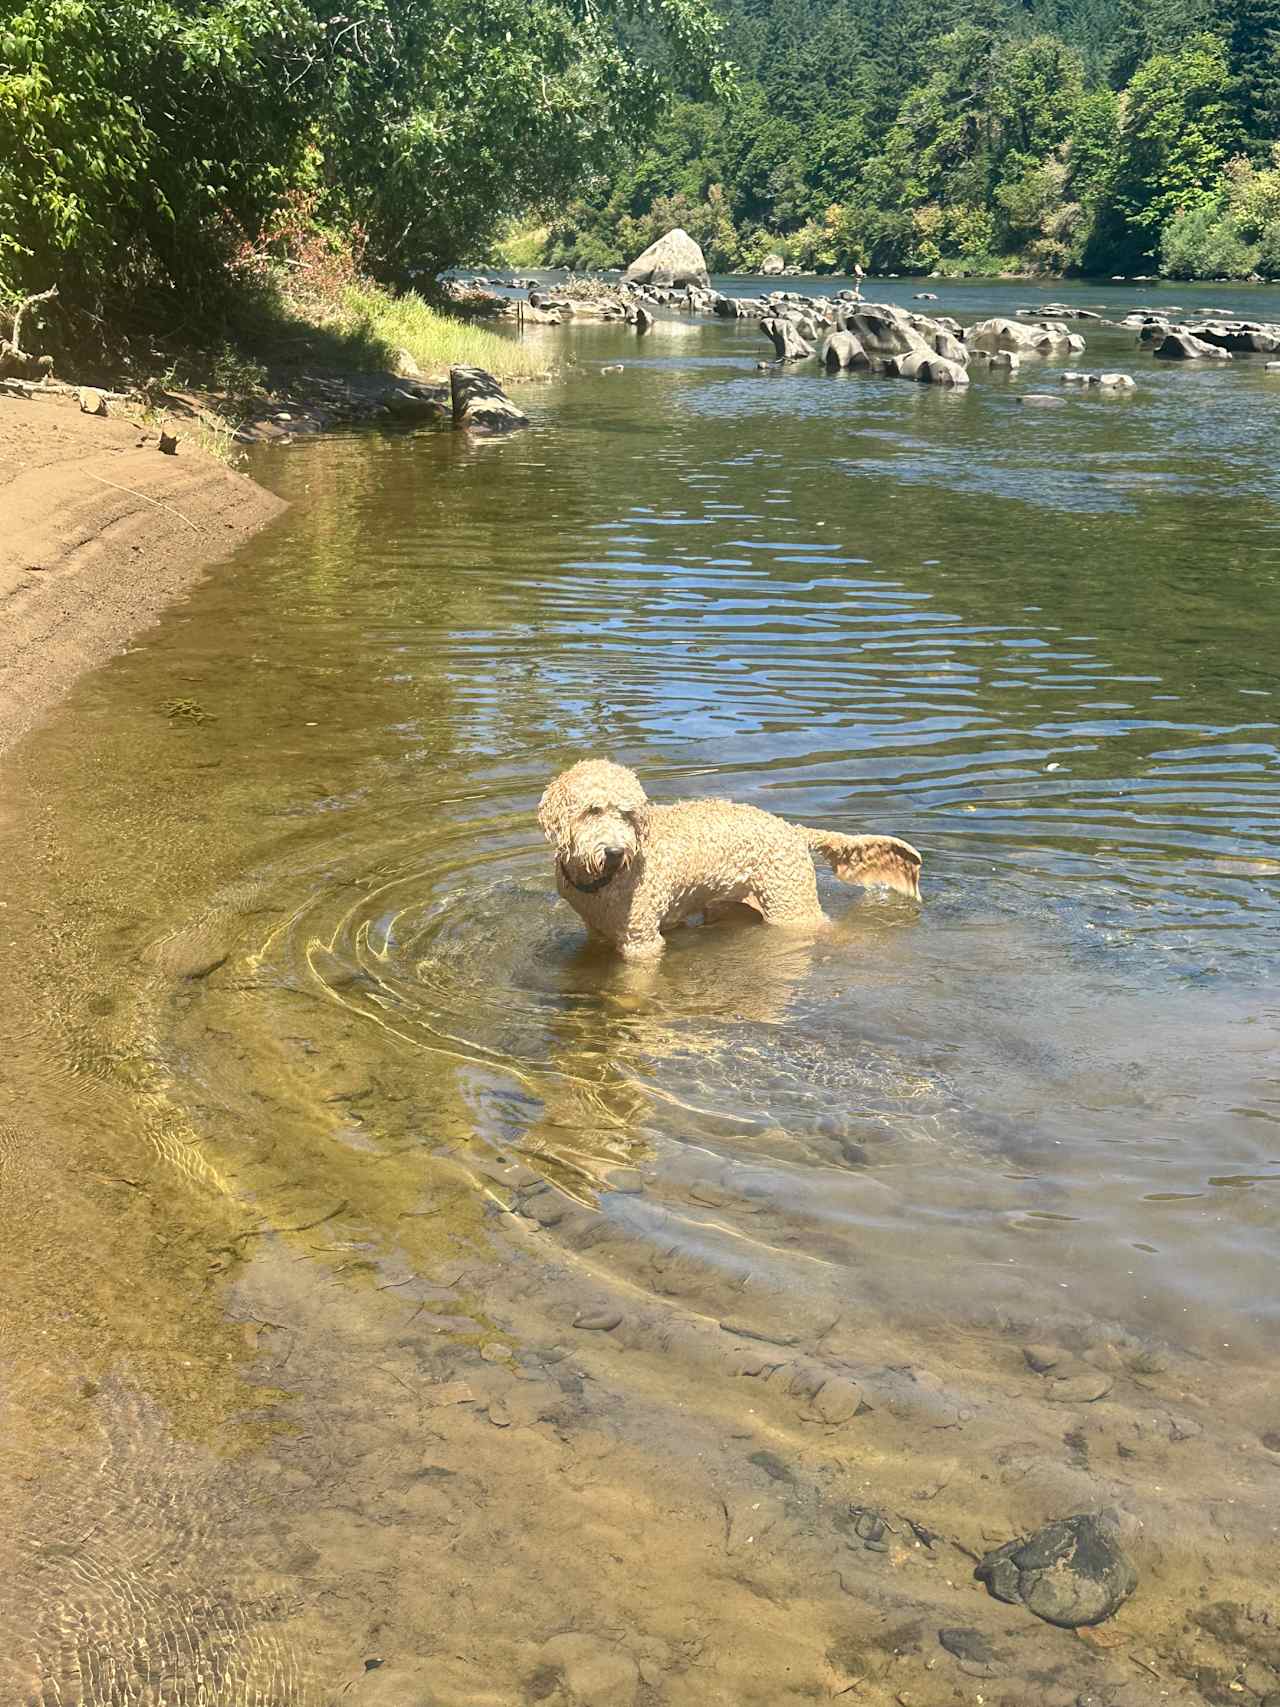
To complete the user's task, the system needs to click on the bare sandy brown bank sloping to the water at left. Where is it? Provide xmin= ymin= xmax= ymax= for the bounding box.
xmin=0 ymin=398 xmax=283 ymax=751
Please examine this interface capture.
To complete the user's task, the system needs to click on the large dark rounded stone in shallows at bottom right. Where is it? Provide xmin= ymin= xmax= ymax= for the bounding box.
xmin=975 ymin=1514 xmax=1138 ymax=1630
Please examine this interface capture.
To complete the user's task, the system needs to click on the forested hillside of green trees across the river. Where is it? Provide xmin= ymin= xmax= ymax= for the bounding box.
xmin=548 ymin=0 xmax=1280 ymax=278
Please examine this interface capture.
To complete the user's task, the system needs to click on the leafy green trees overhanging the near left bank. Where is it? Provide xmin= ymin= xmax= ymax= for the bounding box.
xmin=0 ymin=0 xmax=724 ymax=311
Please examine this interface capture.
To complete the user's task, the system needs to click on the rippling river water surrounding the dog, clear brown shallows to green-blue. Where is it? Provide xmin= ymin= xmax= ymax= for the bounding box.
xmin=0 ymin=283 xmax=1280 ymax=1707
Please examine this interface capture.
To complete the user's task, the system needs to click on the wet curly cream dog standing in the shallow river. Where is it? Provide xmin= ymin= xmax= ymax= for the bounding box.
xmin=538 ymin=760 xmax=920 ymax=959
